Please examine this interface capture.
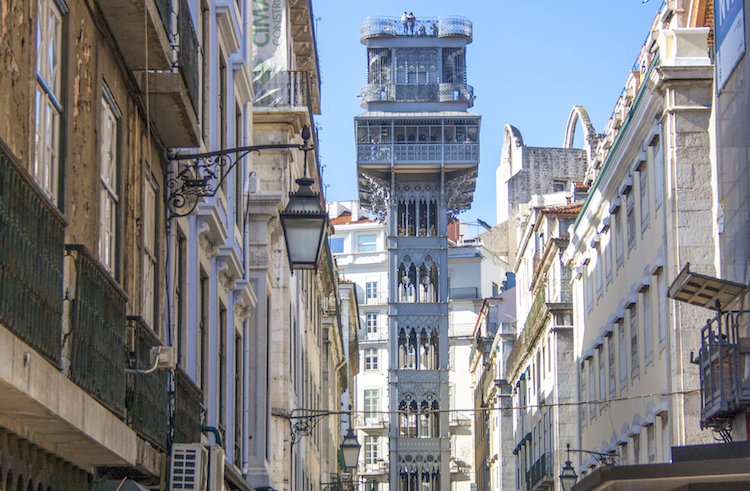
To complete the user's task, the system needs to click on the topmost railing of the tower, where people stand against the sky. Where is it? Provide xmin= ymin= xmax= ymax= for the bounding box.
xmin=359 ymin=17 xmax=472 ymax=43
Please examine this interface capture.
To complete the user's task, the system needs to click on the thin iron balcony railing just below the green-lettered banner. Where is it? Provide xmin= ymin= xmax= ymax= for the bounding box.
xmin=253 ymin=70 xmax=310 ymax=107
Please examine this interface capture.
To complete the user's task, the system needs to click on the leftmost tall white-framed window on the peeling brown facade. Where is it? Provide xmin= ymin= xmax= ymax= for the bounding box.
xmin=34 ymin=0 xmax=63 ymax=203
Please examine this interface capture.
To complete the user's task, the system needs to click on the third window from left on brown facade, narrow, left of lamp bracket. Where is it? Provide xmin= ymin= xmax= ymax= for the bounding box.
xmin=141 ymin=166 xmax=159 ymax=332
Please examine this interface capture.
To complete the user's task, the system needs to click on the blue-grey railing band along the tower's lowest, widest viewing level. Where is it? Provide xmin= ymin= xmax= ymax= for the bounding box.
xmin=357 ymin=142 xmax=479 ymax=165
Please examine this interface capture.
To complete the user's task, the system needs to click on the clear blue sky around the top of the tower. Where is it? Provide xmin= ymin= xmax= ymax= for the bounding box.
xmin=313 ymin=0 xmax=662 ymax=233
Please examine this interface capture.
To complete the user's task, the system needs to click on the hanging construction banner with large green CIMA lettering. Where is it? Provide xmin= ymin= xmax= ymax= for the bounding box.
xmin=251 ymin=0 xmax=289 ymax=88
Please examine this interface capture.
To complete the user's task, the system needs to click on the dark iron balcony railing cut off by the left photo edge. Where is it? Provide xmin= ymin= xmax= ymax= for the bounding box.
xmin=0 ymin=140 xmax=65 ymax=367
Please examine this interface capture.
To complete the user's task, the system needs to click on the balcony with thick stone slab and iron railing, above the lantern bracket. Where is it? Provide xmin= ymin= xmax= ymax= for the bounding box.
xmin=135 ymin=0 xmax=201 ymax=147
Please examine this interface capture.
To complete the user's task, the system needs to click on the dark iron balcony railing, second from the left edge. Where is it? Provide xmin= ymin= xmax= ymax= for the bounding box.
xmin=65 ymin=245 xmax=128 ymax=417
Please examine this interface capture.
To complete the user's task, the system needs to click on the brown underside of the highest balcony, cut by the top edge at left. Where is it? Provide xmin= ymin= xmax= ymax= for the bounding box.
xmin=96 ymin=0 xmax=172 ymax=70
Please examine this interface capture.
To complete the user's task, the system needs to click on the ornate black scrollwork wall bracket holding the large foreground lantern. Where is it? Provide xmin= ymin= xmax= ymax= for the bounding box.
xmin=167 ymin=126 xmax=315 ymax=219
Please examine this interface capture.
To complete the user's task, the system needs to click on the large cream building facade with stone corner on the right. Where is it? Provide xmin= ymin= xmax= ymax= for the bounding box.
xmin=563 ymin=2 xmax=716 ymax=476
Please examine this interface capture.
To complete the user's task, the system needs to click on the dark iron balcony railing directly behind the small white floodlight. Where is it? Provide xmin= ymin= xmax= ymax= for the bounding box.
xmin=126 ymin=316 xmax=169 ymax=450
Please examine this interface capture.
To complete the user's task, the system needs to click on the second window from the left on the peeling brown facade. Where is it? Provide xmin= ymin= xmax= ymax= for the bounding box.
xmin=99 ymin=90 xmax=120 ymax=274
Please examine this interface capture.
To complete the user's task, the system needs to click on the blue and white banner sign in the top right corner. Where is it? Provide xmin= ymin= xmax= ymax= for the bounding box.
xmin=714 ymin=0 xmax=745 ymax=92
